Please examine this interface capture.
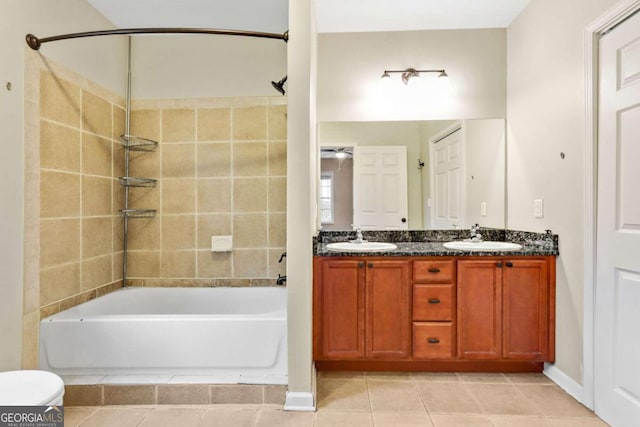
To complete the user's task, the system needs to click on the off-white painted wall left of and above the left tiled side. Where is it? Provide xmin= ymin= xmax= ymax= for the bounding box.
xmin=0 ymin=0 xmax=126 ymax=371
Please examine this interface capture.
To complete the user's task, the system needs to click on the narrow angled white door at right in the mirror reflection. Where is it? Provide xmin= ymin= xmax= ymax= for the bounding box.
xmin=430 ymin=126 xmax=465 ymax=229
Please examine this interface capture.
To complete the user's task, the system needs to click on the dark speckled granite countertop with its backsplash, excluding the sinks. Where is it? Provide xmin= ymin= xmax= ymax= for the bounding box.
xmin=313 ymin=228 xmax=560 ymax=257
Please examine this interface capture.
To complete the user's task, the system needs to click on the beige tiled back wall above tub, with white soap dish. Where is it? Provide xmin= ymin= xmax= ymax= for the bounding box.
xmin=128 ymin=97 xmax=287 ymax=286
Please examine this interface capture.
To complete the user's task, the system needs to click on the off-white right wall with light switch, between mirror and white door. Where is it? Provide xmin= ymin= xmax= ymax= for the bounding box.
xmin=507 ymin=0 xmax=616 ymax=383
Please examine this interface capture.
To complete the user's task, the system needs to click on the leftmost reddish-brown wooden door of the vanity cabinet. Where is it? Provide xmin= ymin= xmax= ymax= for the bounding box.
xmin=315 ymin=259 xmax=365 ymax=359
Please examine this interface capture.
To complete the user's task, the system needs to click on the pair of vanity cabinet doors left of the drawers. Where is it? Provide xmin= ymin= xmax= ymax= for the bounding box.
xmin=314 ymin=257 xmax=411 ymax=360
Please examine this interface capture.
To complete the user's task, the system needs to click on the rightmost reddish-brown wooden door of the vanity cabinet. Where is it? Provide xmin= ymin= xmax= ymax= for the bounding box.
xmin=502 ymin=259 xmax=549 ymax=360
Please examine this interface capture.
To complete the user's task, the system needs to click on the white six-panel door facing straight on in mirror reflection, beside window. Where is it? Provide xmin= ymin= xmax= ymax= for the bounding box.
xmin=353 ymin=146 xmax=408 ymax=230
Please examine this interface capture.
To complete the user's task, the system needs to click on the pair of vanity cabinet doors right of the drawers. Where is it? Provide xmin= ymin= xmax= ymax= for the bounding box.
xmin=457 ymin=258 xmax=555 ymax=361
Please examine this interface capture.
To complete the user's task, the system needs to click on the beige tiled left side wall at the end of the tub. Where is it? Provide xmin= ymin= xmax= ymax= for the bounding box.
xmin=23 ymin=52 xmax=125 ymax=368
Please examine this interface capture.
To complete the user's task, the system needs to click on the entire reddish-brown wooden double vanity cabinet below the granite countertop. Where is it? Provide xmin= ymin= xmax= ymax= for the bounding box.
xmin=313 ymin=256 xmax=555 ymax=372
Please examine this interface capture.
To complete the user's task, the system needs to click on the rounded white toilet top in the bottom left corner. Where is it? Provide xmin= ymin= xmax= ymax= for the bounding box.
xmin=0 ymin=371 xmax=64 ymax=406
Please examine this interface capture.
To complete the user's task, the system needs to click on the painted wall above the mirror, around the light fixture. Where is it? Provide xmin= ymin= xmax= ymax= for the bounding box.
xmin=318 ymin=29 xmax=506 ymax=121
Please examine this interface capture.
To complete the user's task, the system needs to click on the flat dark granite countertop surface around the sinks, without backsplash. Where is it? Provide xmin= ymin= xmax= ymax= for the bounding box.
xmin=314 ymin=242 xmax=559 ymax=257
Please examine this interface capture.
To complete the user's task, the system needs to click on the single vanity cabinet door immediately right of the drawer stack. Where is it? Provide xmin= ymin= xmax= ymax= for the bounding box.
xmin=457 ymin=260 xmax=503 ymax=359
